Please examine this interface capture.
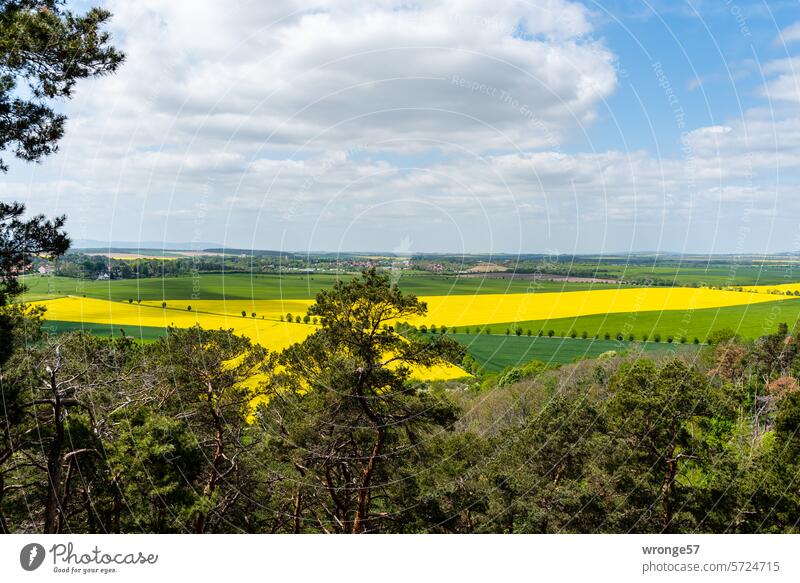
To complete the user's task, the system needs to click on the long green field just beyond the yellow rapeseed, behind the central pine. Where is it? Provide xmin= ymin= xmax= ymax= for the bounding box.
xmin=15 ymin=273 xmax=620 ymax=301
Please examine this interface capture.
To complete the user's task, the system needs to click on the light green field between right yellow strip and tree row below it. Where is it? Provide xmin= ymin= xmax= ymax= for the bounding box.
xmin=491 ymin=299 xmax=800 ymax=342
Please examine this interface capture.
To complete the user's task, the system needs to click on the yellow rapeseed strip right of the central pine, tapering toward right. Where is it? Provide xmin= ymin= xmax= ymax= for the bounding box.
xmin=410 ymin=287 xmax=790 ymax=327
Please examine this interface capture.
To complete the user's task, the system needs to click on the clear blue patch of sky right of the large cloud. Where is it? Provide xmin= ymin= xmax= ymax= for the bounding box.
xmin=585 ymin=0 xmax=800 ymax=155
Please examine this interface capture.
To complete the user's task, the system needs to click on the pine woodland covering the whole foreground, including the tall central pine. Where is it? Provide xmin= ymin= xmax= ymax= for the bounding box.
xmin=0 ymin=271 xmax=800 ymax=533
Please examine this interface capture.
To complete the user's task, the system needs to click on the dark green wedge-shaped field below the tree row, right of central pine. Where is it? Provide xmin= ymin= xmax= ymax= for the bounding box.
xmin=452 ymin=334 xmax=696 ymax=372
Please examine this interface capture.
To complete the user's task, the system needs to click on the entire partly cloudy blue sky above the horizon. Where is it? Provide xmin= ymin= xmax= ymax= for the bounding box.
xmin=0 ymin=0 xmax=800 ymax=254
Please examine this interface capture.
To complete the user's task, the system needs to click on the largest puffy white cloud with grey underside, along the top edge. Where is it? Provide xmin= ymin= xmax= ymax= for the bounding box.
xmin=69 ymin=0 xmax=616 ymax=157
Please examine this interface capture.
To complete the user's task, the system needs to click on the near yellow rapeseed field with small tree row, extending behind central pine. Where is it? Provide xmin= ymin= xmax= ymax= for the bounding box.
xmin=37 ymin=297 xmax=465 ymax=380
